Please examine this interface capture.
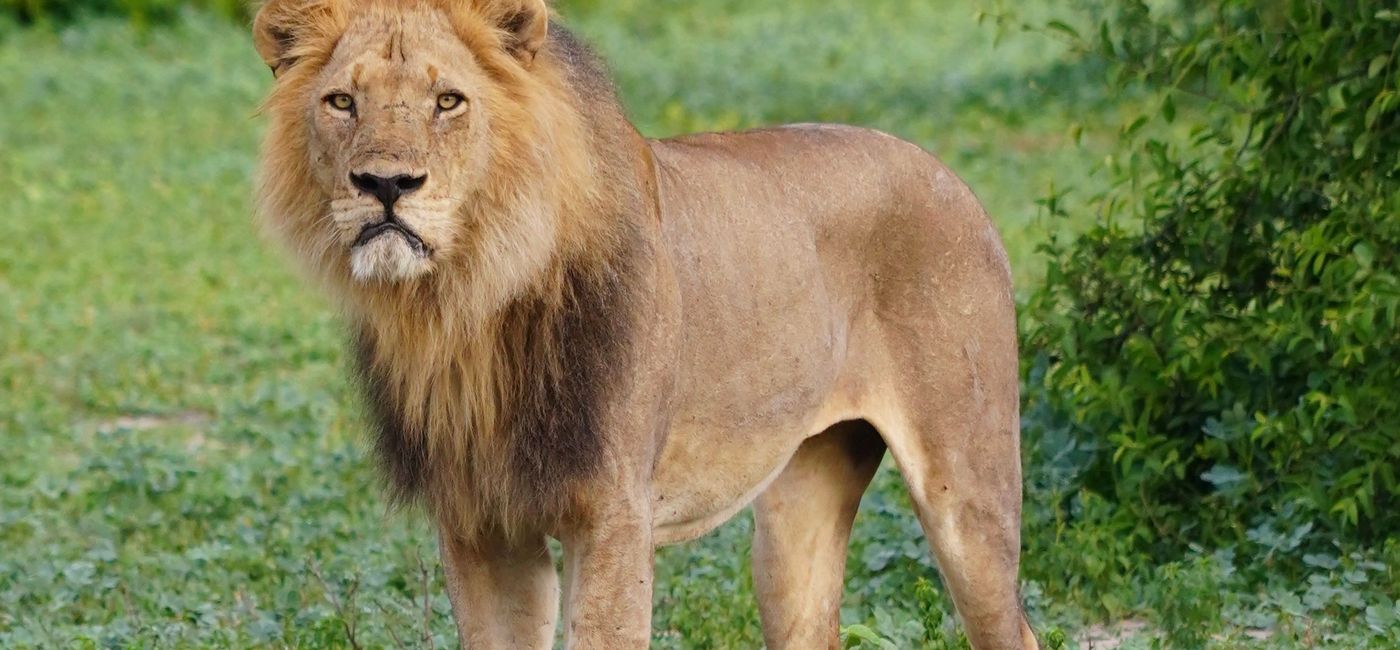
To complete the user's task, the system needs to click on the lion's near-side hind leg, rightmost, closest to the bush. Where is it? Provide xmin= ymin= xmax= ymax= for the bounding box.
xmin=872 ymin=320 xmax=1037 ymax=650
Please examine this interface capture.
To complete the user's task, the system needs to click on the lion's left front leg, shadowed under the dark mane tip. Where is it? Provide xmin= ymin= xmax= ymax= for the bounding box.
xmin=438 ymin=530 xmax=559 ymax=650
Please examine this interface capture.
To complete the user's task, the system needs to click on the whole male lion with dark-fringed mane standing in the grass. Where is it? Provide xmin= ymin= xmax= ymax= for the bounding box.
xmin=253 ymin=0 xmax=1036 ymax=649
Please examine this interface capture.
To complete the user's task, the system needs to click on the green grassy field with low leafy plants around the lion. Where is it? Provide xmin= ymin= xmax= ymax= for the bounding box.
xmin=0 ymin=0 xmax=1393 ymax=649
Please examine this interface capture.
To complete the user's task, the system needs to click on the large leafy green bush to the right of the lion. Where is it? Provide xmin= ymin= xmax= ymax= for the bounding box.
xmin=1022 ymin=0 xmax=1400 ymax=558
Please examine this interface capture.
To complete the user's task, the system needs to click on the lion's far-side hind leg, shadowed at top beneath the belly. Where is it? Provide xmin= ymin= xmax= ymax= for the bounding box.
xmin=753 ymin=420 xmax=885 ymax=650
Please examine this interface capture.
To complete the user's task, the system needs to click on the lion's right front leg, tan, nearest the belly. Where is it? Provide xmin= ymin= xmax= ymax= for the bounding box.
xmin=563 ymin=499 xmax=652 ymax=650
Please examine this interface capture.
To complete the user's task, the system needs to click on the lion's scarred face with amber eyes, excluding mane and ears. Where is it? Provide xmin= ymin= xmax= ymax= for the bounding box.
xmin=302 ymin=11 xmax=491 ymax=282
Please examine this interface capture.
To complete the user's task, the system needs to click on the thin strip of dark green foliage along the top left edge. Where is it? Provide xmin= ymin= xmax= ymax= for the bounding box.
xmin=0 ymin=0 xmax=255 ymax=25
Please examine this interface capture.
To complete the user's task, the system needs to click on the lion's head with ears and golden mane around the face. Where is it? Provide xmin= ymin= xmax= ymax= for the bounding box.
xmin=253 ymin=0 xmax=571 ymax=298
